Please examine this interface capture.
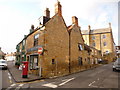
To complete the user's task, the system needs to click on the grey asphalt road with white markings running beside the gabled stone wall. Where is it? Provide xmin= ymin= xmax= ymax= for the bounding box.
xmin=3 ymin=63 xmax=120 ymax=90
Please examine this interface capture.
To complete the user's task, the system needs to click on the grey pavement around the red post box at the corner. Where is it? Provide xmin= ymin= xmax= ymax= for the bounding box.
xmin=8 ymin=61 xmax=41 ymax=83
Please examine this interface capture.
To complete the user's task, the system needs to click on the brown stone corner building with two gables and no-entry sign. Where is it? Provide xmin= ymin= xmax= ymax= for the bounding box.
xmin=16 ymin=1 xmax=101 ymax=78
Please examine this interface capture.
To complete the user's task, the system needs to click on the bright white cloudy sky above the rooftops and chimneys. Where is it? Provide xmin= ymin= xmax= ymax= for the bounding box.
xmin=0 ymin=0 xmax=119 ymax=53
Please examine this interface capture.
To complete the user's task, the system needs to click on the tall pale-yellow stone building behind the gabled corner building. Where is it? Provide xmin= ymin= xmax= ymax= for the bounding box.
xmin=82 ymin=23 xmax=115 ymax=62
